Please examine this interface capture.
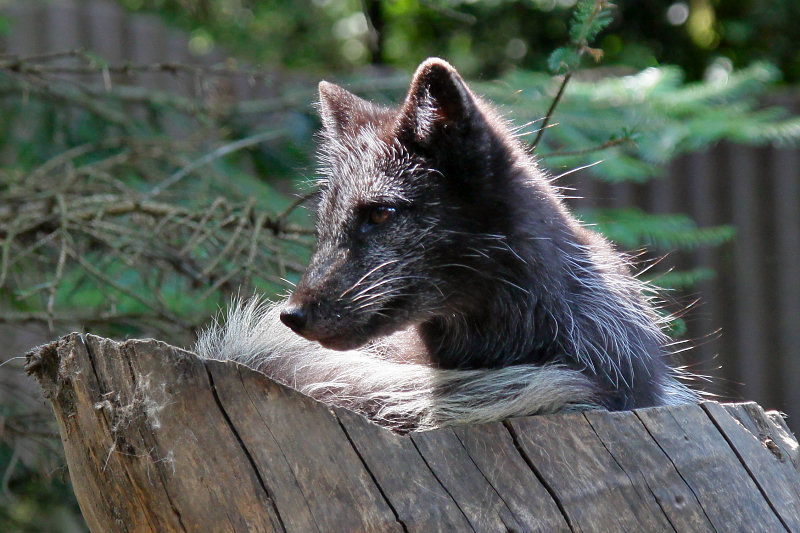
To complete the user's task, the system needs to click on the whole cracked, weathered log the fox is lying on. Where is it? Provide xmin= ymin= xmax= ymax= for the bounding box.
xmin=27 ymin=334 xmax=800 ymax=532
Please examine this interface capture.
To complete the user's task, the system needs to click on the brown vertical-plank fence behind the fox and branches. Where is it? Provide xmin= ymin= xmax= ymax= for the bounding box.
xmin=0 ymin=0 xmax=800 ymax=431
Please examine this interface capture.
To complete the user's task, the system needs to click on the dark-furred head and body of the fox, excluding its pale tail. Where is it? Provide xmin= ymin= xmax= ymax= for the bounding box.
xmin=201 ymin=59 xmax=695 ymax=427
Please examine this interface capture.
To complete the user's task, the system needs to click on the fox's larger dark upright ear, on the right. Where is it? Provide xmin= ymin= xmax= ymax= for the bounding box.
xmin=398 ymin=57 xmax=478 ymax=144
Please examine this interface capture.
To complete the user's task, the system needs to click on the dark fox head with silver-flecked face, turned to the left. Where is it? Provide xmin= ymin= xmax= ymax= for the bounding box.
xmin=281 ymin=59 xmax=552 ymax=349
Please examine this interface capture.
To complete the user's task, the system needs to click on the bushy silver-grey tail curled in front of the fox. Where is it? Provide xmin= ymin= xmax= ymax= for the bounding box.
xmin=195 ymin=296 xmax=598 ymax=431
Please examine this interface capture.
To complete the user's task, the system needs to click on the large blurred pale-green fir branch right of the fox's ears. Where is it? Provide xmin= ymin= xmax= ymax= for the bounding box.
xmin=480 ymin=63 xmax=800 ymax=183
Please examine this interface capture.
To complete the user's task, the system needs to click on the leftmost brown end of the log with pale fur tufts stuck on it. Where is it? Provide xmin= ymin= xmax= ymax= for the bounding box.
xmin=28 ymin=335 xmax=280 ymax=531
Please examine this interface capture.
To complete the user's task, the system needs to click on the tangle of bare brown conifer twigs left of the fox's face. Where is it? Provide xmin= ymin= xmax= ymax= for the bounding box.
xmin=0 ymin=51 xmax=322 ymax=339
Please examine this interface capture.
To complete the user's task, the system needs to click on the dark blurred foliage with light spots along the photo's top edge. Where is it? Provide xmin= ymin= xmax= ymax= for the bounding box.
xmin=118 ymin=0 xmax=800 ymax=82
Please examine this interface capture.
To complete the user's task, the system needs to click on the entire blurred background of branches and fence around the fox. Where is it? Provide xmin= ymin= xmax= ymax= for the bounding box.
xmin=0 ymin=0 xmax=800 ymax=531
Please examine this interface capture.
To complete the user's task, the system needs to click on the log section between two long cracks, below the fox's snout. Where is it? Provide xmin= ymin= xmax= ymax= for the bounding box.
xmin=206 ymin=361 xmax=402 ymax=531
